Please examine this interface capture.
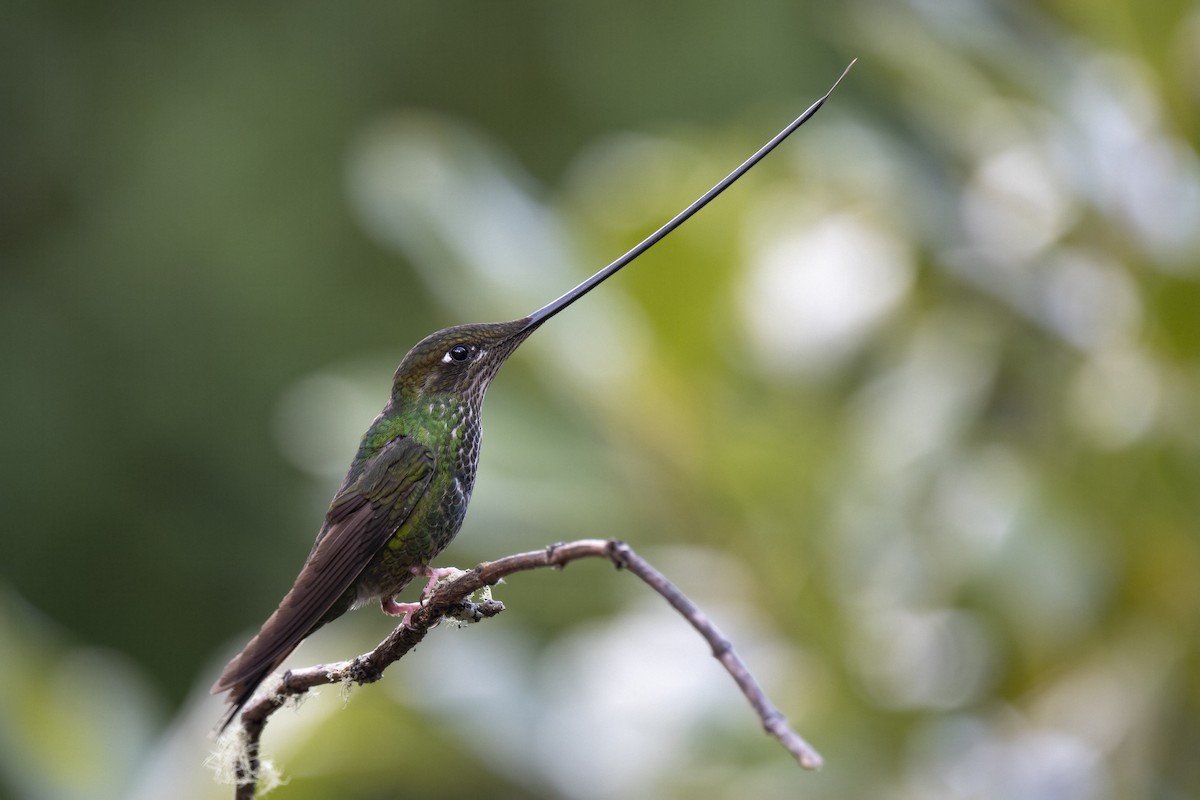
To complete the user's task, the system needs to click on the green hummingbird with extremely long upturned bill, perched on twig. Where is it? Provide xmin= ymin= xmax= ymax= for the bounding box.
xmin=212 ymin=61 xmax=854 ymax=730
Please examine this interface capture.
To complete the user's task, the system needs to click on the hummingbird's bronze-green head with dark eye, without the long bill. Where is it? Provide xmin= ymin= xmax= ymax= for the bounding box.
xmin=391 ymin=317 xmax=538 ymax=403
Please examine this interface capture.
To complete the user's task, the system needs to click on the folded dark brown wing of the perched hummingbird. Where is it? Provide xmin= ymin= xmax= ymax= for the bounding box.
xmin=212 ymin=437 xmax=436 ymax=729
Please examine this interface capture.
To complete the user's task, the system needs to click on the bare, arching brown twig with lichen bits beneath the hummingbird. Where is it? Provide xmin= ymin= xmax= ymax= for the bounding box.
xmin=223 ymin=539 xmax=821 ymax=800
